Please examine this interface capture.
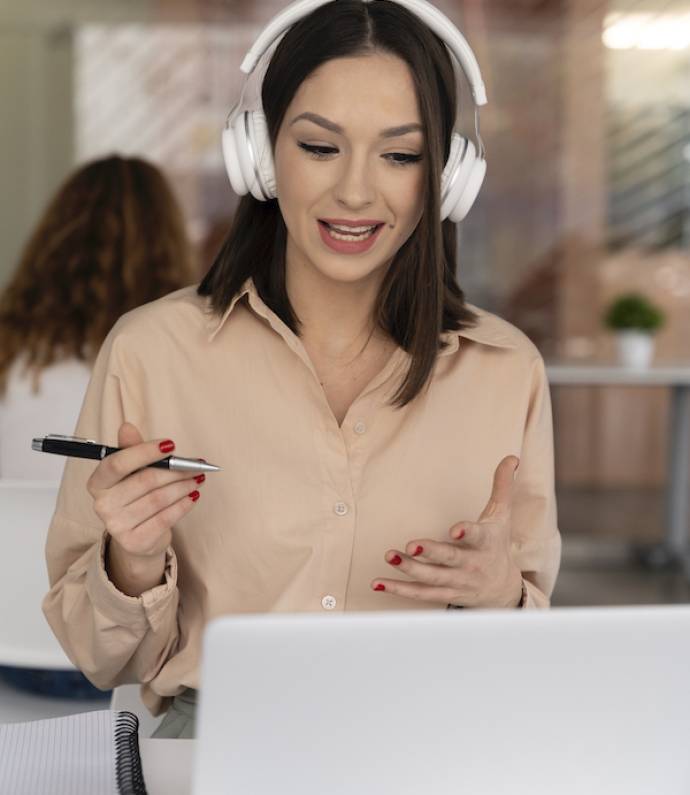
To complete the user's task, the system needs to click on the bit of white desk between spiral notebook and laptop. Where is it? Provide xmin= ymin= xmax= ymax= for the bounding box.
xmin=139 ymin=737 xmax=196 ymax=795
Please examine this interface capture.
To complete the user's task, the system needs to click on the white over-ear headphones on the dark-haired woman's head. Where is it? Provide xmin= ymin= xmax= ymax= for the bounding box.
xmin=222 ymin=0 xmax=486 ymax=221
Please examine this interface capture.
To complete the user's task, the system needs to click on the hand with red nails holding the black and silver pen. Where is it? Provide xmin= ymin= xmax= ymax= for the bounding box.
xmin=86 ymin=422 xmax=205 ymax=591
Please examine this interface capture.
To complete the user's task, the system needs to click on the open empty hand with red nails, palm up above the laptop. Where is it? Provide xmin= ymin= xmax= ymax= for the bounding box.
xmin=371 ymin=456 xmax=522 ymax=607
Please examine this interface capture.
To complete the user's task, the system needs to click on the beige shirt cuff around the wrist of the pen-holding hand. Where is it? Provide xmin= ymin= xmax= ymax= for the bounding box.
xmin=86 ymin=531 xmax=177 ymax=631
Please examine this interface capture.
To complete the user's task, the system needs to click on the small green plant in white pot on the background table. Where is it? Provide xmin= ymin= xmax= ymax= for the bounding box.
xmin=604 ymin=293 xmax=665 ymax=368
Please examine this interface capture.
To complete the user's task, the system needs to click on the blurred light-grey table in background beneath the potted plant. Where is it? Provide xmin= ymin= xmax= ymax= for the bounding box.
xmin=546 ymin=361 xmax=690 ymax=576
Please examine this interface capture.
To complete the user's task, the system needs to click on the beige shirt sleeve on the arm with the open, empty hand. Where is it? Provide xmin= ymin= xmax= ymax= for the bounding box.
xmin=512 ymin=355 xmax=561 ymax=608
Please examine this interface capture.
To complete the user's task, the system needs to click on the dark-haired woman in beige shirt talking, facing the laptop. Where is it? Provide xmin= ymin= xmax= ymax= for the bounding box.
xmin=44 ymin=0 xmax=560 ymax=737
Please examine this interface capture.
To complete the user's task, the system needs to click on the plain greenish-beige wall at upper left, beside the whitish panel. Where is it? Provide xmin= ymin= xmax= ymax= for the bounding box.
xmin=0 ymin=0 xmax=155 ymax=288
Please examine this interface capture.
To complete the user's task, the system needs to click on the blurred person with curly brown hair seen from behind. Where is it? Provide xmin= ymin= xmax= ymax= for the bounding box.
xmin=0 ymin=155 xmax=195 ymax=696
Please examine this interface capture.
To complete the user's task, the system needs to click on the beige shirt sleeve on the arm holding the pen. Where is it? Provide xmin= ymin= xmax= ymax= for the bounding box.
xmin=43 ymin=322 xmax=179 ymax=690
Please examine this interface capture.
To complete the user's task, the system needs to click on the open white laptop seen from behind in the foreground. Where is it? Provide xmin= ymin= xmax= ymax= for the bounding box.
xmin=193 ymin=605 xmax=690 ymax=795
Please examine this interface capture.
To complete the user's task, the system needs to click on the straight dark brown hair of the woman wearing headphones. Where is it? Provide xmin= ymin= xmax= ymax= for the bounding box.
xmin=198 ymin=0 xmax=476 ymax=407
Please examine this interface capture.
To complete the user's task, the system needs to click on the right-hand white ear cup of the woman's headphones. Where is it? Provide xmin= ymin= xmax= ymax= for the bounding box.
xmin=441 ymin=133 xmax=486 ymax=223
